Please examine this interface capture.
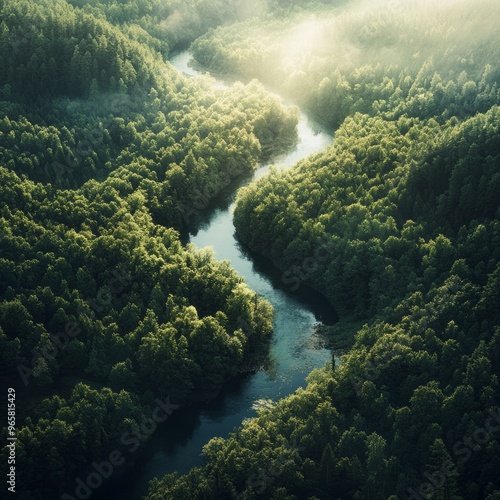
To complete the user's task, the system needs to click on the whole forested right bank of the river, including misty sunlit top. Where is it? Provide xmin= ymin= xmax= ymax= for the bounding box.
xmin=148 ymin=1 xmax=500 ymax=500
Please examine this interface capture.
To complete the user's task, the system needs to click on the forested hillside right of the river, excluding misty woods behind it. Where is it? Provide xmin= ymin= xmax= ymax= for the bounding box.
xmin=156 ymin=107 xmax=500 ymax=500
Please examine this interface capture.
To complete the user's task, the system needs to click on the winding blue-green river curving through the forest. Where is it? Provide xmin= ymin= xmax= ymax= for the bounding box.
xmin=95 ymin=51 xmax=336 ymax=500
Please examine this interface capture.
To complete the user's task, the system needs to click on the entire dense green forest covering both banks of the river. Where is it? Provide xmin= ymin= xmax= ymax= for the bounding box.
xmin=0 ymin=0 xmax=500 ymax=500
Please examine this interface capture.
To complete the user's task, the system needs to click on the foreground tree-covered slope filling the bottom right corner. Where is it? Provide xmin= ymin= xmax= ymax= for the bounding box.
xmin=147 ymin=256 xmax=500 ymax=500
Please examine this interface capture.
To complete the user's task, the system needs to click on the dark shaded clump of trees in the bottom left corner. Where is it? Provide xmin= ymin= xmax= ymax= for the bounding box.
xmin=9 ymin=383 xmax=147 ymax=498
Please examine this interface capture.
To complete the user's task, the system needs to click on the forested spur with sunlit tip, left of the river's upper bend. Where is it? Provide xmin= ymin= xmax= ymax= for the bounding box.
xmin=0 ymin=62 xmax=297 ymax=201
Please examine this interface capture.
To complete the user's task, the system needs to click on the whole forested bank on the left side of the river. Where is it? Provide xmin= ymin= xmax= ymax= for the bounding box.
xmin=0 ymin=0 xmax=297 ymax=499
